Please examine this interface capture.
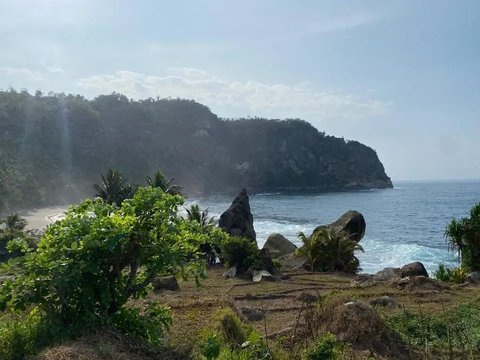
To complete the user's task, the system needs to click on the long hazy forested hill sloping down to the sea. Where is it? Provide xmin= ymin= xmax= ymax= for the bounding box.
xmin=0 ymin=90 xmax=392 ymax=211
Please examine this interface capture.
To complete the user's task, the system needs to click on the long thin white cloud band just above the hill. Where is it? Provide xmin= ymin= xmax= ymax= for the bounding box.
xmin=76 ymin=68 xmax=390 ymax=120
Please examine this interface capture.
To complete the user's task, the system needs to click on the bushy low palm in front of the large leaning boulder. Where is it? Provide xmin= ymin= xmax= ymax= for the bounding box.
xmin=297 ymin=228 xmax=363 ymax=273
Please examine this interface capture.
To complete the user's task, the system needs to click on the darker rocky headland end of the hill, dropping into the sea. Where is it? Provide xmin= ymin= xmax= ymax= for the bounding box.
xmin=210 ymin=119 xmax=392 ymax=191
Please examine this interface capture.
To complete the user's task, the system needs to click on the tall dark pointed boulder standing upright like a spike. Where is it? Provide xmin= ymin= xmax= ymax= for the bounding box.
xmin=218 ymin=189 xmax=257 ymax=241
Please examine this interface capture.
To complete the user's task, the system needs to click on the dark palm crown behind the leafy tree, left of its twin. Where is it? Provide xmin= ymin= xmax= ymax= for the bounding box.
xmin=93 ymin=169 xmax=136 ymax=206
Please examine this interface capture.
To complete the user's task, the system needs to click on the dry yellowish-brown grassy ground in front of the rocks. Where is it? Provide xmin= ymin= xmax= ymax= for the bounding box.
xmin=38 ymin=267 xmax=480 ymax=360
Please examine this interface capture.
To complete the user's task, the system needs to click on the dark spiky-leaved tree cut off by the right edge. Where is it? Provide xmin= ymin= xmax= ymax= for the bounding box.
xmin=445 ymin=203 xmax=480 ymax=271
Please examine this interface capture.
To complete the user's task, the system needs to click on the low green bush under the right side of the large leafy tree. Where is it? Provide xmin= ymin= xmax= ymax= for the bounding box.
xmin=111 ymin=303 xmax=172 ymax=346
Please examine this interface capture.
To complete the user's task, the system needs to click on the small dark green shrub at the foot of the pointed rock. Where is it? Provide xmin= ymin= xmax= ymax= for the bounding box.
xmin=220 ymin=236 xmax=260 ymax=273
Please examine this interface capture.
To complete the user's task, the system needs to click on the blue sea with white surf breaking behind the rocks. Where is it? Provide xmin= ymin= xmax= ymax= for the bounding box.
xmin=186 ymin=180 xmax=480 ymax=273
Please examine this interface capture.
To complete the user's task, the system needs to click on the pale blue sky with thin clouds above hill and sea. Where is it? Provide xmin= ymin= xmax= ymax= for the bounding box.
xmin=0 ymin=0 xmax=480 ymax=181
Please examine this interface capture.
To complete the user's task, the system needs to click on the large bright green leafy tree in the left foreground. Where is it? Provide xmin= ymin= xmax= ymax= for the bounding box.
xmin=0 ymin=187 xmax=205 ymax=324
